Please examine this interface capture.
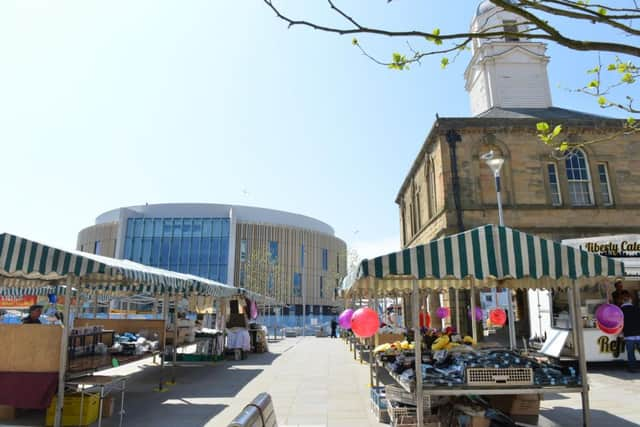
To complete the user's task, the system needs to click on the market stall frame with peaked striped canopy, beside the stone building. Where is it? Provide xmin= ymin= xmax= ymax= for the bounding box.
xmin=343 ymin=225 xmax=624 ymax=426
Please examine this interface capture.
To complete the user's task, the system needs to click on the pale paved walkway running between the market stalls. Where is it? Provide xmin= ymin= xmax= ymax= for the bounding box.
xmin=5 ymin=337 xmax=640 ymax=427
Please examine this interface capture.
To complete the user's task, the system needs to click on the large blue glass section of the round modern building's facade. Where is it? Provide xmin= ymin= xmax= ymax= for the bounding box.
xmin=124 ymin=218 xmax=230 ymax=283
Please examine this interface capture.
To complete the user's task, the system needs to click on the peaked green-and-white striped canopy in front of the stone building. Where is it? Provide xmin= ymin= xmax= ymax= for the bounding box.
xmin=342 ymin=225 xmax=624 ymax=297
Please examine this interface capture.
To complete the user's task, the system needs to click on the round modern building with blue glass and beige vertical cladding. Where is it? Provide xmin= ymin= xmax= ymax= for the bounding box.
xmin=77 ymin=203 xmax=347 ymax=315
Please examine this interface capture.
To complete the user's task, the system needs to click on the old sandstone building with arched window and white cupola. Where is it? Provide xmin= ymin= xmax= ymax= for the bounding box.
xmin=396 ymin=1 xmax=640 ymax=338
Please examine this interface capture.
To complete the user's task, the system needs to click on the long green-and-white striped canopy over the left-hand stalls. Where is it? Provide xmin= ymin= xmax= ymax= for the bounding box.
xmin=0 ymin=233 xmax=240 ymax=297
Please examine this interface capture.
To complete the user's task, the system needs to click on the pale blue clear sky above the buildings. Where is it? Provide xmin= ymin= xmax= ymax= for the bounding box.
xmin=0 ymin=0 xmax=632 ymax=257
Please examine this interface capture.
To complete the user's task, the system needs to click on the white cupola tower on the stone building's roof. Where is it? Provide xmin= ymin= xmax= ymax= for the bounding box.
xmin=465 ymin=0 xmax=551 ymax=116
